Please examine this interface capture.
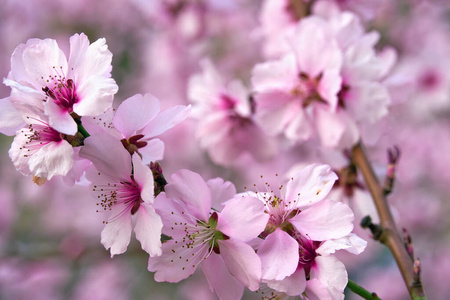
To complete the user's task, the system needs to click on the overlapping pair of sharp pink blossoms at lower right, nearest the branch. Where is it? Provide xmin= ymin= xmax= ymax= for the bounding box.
xmin=249 ymin=165 xmax=365 ymax=299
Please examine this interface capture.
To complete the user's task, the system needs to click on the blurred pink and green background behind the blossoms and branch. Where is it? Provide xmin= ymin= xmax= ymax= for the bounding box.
xmin=0 ymin=0 xmax=450 ymax=300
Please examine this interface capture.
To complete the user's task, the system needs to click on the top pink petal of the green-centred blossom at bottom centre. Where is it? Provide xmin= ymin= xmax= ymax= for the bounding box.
xmin=165 ymin=170 xmax=211 ymax=221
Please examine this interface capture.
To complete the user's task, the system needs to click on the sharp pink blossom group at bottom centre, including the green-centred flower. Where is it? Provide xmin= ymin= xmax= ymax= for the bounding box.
xmin=148 ymin=165 xmax=366 ymax=299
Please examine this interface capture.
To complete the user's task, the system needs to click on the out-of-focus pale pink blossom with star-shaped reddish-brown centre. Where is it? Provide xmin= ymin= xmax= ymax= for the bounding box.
xmin=252 ymin=17 xmax=342 ymax=145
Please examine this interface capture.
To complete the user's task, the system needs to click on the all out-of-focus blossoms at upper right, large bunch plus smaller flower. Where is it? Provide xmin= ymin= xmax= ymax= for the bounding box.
xmin=188 ymin=0 xmax=396 ymax=169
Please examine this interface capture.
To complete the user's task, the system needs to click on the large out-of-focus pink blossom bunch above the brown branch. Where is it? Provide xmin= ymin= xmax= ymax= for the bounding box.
xmin=252 ymin=7 xmax=396 ymax=149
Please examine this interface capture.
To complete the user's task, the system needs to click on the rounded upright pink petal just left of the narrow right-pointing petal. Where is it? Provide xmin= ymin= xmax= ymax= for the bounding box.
xmin=113 ymin=94 xmax=160 ymax=139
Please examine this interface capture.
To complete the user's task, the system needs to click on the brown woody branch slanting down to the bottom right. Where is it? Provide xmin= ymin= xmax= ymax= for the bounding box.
xmin=352 ymin=142 xmax=426 ymax=299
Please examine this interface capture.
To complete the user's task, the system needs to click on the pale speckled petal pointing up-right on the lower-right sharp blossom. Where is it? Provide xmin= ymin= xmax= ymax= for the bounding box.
xmin=285 ymin=165 xmax=338 ymax=207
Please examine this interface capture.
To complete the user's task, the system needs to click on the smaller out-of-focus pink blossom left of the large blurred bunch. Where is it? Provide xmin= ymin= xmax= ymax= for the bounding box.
xmin=188 ymin=60 xmax=276 ymax=165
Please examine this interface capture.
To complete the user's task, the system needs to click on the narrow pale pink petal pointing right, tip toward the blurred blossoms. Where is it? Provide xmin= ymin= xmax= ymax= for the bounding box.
xmin=143 ymin=105 xmax=191 ymax=138
